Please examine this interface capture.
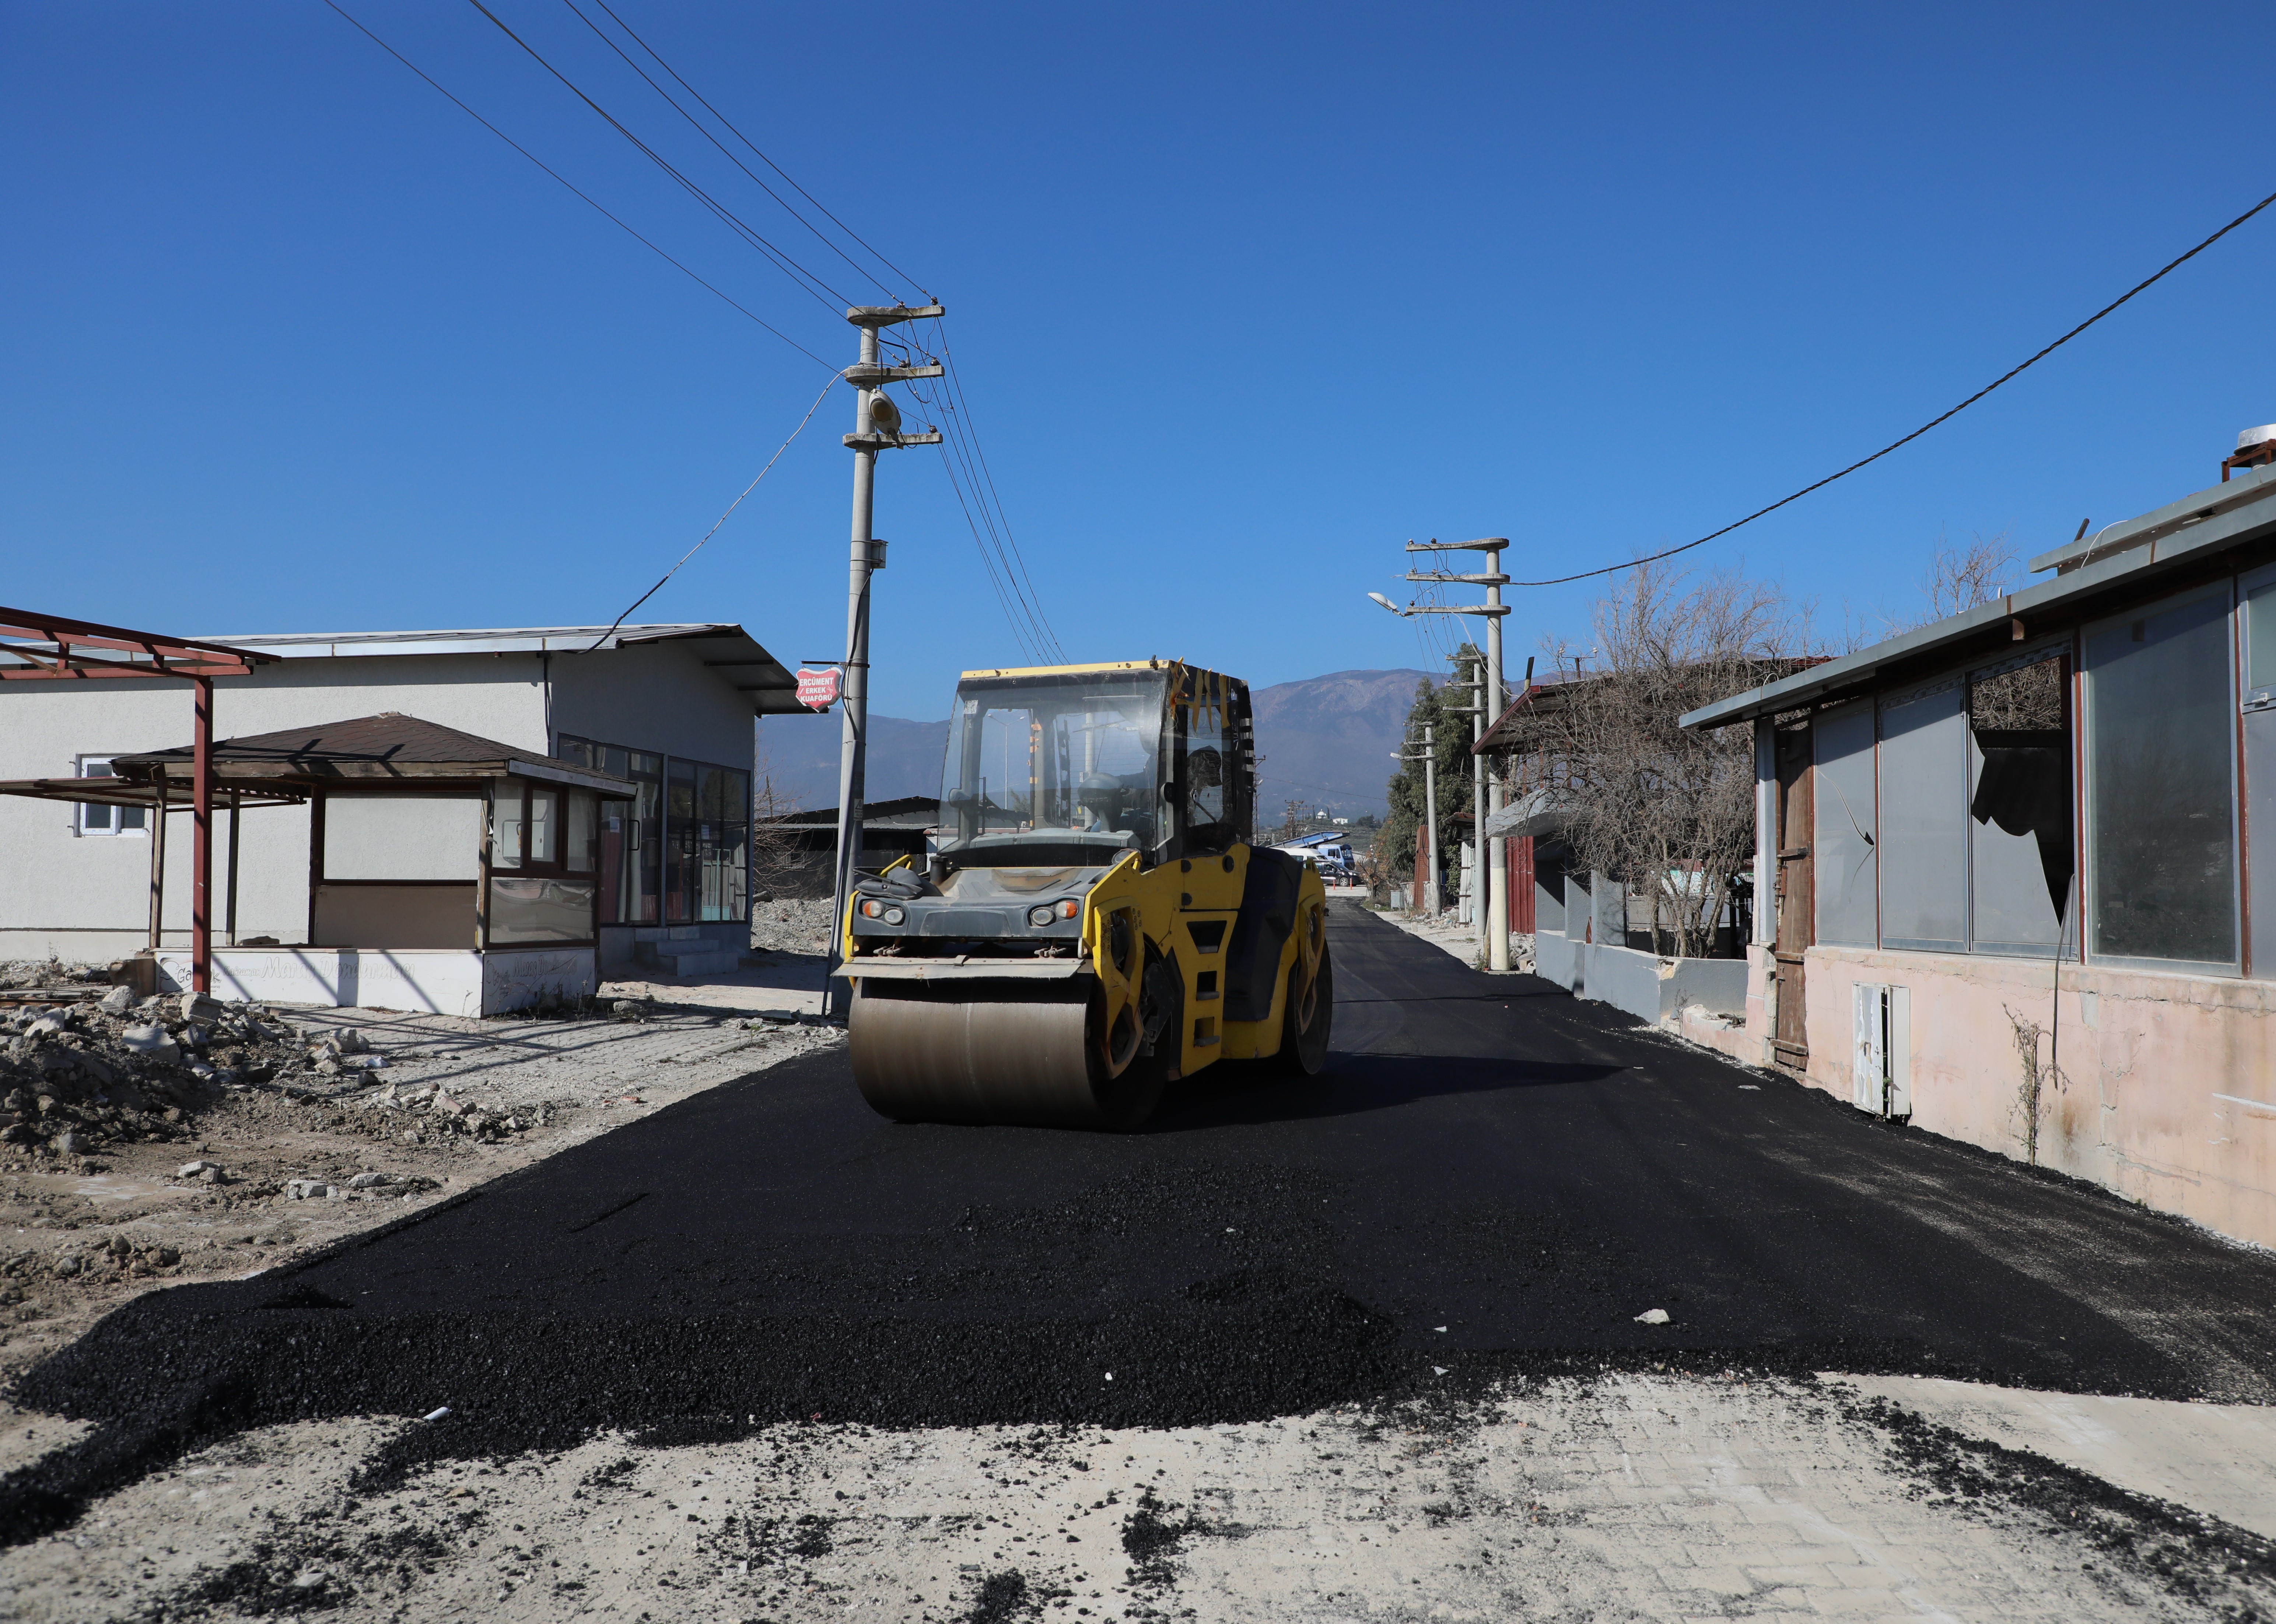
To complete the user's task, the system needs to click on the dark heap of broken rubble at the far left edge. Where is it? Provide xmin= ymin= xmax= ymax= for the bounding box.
xmin=0 ymin=987 xmax=328 ymax=1155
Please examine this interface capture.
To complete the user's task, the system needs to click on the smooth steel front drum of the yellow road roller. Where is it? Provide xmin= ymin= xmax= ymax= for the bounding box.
xmin=847 ymin=980 xmax=1161 ymax=1130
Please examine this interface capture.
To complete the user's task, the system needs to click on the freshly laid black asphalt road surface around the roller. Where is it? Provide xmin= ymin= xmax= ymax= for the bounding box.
xmin=0 ymin=905 xmax=2276 ymax=1537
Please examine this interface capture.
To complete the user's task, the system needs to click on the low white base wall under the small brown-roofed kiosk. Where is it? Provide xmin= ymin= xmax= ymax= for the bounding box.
xmin=157 ymin=948 xmax=601 ymax=1014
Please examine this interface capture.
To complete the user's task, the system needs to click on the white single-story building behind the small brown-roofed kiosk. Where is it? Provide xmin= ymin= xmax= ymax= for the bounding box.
xmin=0 ymin=625 xmax=801 ymax=1003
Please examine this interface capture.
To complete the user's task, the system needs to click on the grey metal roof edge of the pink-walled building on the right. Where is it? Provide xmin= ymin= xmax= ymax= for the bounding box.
xmin=1680 ymin=469 xmax=2276 ymax=728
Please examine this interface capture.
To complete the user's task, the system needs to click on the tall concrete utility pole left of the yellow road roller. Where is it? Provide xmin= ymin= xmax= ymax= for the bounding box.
xmin=822 ymin=305 xmax=942 ymax=1014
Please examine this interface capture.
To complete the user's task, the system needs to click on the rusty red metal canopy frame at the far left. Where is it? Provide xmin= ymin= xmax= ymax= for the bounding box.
xmin=0 ymin=607 xmax=278 ymax=992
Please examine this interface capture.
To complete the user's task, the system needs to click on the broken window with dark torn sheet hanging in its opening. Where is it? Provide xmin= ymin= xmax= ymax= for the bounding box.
xmin=1969 ymin=650 xmax=2073 ymax=955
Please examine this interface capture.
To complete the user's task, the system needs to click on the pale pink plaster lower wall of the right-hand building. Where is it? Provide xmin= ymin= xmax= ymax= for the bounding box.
xmin=1793 ymin=946 xmax=2276 ymax=1246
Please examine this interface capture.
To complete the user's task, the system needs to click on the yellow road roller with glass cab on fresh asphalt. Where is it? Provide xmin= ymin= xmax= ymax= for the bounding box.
xmin=838 ymin=660 xmax=1334 ymax=1130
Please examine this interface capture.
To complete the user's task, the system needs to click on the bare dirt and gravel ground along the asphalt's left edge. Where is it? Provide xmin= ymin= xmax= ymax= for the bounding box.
xmin=0 ymin=1008 xmax=840 ymax=1474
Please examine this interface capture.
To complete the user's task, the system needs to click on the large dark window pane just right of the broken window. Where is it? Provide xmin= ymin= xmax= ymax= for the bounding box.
xmin=2085 ymin=582 xmax=2237 ymax=969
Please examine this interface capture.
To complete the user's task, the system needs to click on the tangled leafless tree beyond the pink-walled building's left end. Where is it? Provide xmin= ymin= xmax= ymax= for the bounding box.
xmin=1518 ymin=564 xmax=1803 ymax=955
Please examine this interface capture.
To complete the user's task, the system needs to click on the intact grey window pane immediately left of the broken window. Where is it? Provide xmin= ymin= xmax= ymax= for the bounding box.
xmin=1875 ymin=676 xmax=1969 ymax=953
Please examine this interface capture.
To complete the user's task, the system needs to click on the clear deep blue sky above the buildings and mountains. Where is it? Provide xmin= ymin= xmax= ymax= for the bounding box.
xmin=0 ymin=0 xmax=2276 ymax=716
